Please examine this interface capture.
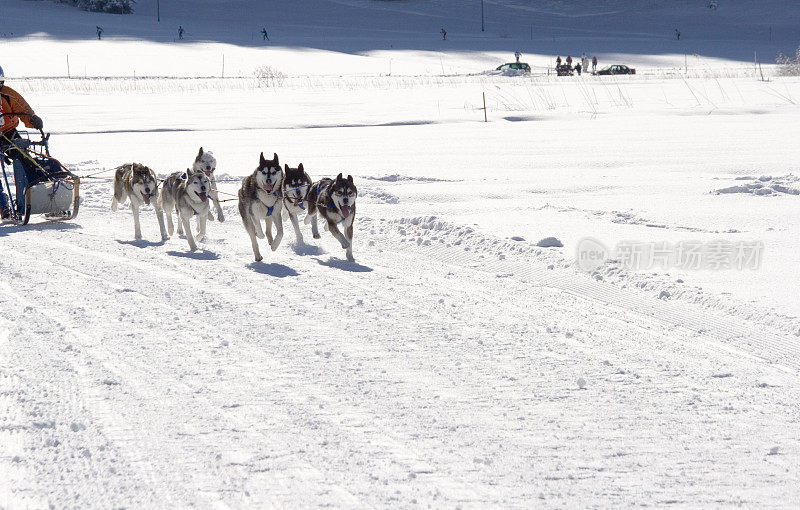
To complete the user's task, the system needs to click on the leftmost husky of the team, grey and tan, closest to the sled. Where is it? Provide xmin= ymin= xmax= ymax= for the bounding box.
xmin=111 ymin=163 xmax=169 ymax=241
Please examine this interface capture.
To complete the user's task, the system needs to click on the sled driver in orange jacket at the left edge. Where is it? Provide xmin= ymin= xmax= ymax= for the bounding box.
xmin=0 ymin=67 xmax=44 ymax=219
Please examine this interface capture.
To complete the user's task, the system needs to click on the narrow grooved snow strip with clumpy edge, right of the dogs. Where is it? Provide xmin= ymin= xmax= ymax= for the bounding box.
xmin=379 ymin=217 xmax=800 ymax=375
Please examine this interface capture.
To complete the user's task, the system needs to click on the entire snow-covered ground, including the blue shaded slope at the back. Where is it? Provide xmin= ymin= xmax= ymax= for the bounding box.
xmin=0 ymin=0 xmax=800 ymax=509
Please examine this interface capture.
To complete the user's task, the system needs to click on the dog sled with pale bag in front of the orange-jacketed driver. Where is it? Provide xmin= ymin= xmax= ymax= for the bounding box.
xmin=0 ymin=132 xmax=80 ymax=225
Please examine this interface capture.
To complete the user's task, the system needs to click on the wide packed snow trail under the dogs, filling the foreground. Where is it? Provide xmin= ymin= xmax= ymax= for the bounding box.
xmin=0 ymin=176 xmax=800 ymax=508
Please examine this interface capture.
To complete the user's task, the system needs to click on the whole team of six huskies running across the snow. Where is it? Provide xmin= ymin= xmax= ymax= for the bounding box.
xmin=111 ymin=147 xmax=358 ymax=262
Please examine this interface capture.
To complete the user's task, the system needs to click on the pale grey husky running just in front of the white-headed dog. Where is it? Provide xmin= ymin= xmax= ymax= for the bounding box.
xmin=158 ymin=168 xmax=211 ymax=251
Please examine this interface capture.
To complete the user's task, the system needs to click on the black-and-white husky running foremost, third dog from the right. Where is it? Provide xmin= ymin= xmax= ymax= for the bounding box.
xmin=239 ymin=152 xmax=283 ymax=262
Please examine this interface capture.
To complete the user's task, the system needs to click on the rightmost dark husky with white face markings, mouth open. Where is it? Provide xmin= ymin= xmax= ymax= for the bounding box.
xmin=305 ymin=174 xmax=358 ymax=262
